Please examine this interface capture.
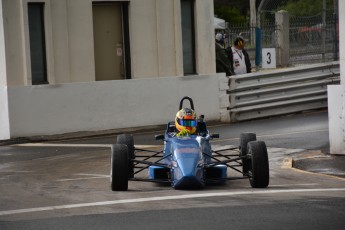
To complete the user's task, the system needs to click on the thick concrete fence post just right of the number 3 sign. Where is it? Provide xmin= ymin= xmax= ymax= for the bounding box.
xmin=275 ymin=10 xmax=290 ymax=67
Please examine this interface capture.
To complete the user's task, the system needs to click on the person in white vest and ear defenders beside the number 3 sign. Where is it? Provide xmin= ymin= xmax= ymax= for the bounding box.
xmin=226 ymin=36 xmax=252 ymax=74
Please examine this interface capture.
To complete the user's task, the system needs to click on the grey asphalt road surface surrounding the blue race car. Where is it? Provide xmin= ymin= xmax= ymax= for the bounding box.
xmin=0 ymin=112 xmax=345 ymax=230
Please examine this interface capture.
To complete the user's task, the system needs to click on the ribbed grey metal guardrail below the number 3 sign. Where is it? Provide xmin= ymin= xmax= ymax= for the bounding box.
xmin=227 ymin=62 xmax=340 ymax=122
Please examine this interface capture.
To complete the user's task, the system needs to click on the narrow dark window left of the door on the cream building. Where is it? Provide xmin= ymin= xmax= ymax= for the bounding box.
xmin=28 ymin=3 xmax=48 ymax=85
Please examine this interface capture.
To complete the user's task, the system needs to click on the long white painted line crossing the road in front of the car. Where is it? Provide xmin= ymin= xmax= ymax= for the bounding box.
xmin=0 ymin=188 xmax=345 ymax=216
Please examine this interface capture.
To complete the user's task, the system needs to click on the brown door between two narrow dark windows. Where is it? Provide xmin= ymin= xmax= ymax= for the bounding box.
xmin=92 ymin=3 xmax=125 ymax=81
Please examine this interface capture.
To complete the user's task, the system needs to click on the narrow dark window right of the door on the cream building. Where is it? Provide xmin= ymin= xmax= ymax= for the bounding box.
xmin=181 ymin=0 xmax=196 ymax=75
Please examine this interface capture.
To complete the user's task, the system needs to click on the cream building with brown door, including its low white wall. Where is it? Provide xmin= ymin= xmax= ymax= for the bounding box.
xmin=0 ymin=0 xmax=226 ymax=140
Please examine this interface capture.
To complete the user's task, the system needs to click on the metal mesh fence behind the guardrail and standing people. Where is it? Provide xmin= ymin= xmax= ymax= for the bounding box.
xmin=227 ymin=0 xmax=339 ymax=66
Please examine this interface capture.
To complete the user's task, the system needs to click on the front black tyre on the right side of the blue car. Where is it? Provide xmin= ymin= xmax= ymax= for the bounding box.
xmin=248 ymin=141 xmax=269 ymax=188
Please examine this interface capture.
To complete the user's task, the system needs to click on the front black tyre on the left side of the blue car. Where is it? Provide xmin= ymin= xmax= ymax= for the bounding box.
xmin=110 ymin=144 xmax=128 ymax=191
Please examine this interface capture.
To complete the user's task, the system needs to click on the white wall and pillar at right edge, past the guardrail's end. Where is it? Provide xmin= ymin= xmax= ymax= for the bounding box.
xmin=328 ymin=1 xmax=345 ymax=155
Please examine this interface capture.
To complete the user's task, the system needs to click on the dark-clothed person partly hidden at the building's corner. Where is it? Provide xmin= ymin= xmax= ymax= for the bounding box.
xmin=216 ymin=33 xmax=233 ymax=76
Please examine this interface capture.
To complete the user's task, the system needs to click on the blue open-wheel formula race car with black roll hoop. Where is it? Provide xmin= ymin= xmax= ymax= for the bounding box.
xmin=110 ymin=97 xmax=269 ymax=191
